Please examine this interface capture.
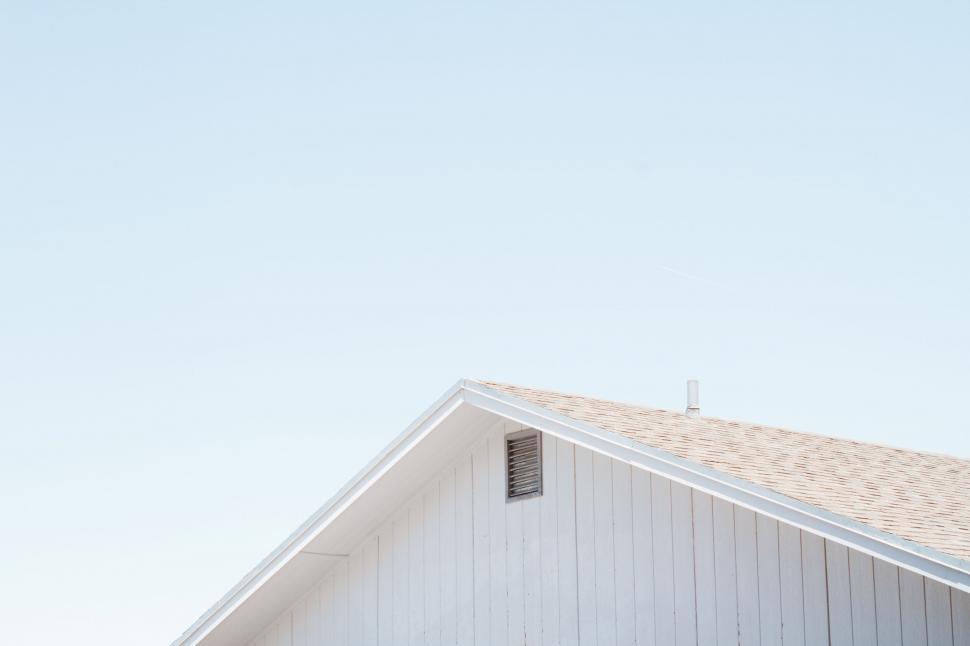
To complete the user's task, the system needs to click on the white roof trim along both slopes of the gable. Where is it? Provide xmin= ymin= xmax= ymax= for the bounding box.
xmin=172 ymin=380 xmax=970 ymax=646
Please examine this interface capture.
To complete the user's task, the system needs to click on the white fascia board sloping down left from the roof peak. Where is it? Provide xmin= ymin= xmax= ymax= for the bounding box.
xmin=172 ymin=380 xmax=468 ymax=646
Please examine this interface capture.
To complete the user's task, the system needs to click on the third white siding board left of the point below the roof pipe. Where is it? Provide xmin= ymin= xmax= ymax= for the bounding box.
xmin=630 ymin=469 xmax=656 ymax=646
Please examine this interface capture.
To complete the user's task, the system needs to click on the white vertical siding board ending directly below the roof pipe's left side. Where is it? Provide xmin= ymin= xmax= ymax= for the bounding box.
xmin=670 ymin=482 xmax=697 ymax=646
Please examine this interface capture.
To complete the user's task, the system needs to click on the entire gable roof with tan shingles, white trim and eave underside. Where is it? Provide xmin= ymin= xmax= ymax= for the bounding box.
xmin=173 ymin=380 xmax=970 ymax=646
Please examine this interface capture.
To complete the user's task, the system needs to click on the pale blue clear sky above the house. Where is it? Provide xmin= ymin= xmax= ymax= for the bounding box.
xmin=0 ymin=2 xmax=970 ymax=646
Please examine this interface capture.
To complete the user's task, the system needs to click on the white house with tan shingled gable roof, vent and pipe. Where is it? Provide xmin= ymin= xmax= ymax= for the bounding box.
xmin=175 ymin=380 xmax=970 ymax=646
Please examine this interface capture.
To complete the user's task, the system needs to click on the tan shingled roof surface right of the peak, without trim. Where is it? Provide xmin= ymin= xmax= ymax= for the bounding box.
xmin=481 ymin=382 xmax=970 ymax=561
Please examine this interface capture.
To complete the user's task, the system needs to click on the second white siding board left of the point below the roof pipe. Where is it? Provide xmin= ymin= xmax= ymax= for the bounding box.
xmin=650 ymin=474 xmax=676 ymax=646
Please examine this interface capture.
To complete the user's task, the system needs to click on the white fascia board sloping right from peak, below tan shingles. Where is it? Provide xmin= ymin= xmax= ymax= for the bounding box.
xmin=464 ymin=381 xmax=970 ymax=592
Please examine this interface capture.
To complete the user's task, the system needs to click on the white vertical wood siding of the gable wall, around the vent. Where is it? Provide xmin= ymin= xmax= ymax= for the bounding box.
xmin=251 ymin=423 xmax=970 ymax=646
